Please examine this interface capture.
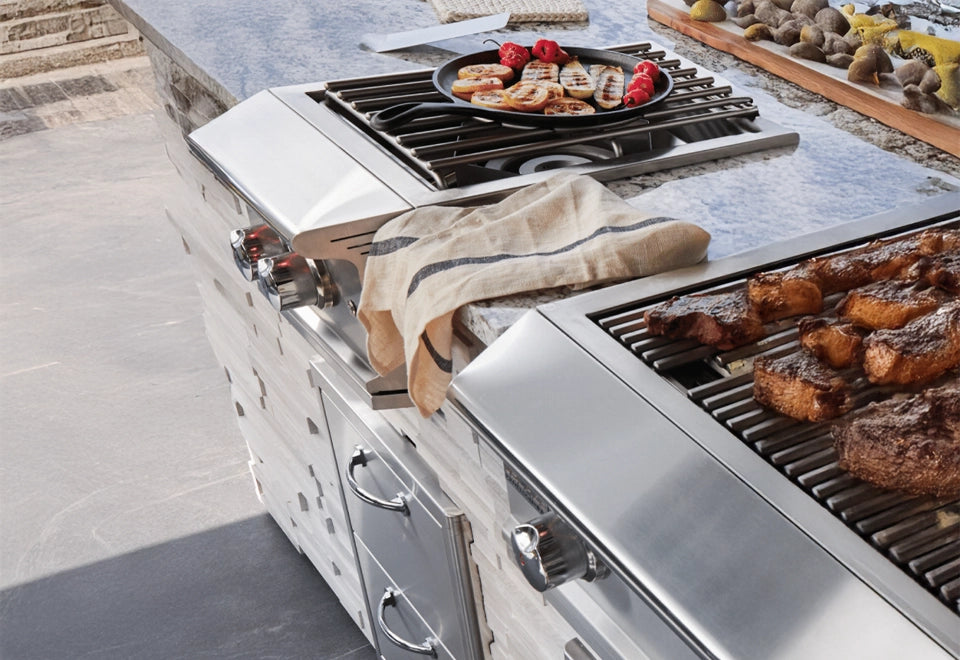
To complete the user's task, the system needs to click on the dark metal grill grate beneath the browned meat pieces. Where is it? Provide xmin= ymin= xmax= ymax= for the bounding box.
xmin=597 ymin=227 xmax=960 ymax=613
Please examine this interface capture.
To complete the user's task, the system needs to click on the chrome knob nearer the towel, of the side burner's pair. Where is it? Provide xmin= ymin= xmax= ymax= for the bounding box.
xmin=257 ymin=252 xmax=336 ymax=312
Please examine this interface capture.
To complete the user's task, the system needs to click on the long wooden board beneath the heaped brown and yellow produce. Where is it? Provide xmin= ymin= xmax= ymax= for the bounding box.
xmin=647 ymin=0 xmax=960 ymax=157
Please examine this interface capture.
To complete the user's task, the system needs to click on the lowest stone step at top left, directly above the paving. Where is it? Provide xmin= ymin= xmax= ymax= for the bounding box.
xmin=0 ymin=28 xmax=145 ymax=81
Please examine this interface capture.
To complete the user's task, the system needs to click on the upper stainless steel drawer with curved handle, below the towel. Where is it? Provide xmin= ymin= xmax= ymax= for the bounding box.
xmin=312 ymin=358 xmax=483 ymax=658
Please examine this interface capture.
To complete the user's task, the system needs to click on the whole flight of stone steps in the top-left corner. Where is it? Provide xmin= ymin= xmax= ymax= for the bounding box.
xmin=0 ymin=0 xmax=144 ymax=78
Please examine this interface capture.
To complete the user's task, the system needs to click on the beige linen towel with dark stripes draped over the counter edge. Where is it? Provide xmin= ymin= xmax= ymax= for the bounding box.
xmin=357 ymin=173 xmax=710 ymax=417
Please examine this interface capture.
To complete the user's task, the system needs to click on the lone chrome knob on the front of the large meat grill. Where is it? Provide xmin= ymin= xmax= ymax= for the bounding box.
xmin=510 ymin=514 xmax=608 ymax=591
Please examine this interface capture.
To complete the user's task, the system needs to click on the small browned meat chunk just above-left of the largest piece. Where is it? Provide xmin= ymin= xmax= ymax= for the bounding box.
xmin=753 ymin=351 xmax=852 ymax=422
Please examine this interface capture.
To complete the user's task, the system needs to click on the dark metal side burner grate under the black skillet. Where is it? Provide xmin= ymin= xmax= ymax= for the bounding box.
xmin=323 ymin=43 xmax=792 ymax=188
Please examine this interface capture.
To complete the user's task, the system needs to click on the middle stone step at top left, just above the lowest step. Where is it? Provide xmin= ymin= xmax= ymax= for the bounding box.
xmin=0 ymin=5 xmax=130 ymax=55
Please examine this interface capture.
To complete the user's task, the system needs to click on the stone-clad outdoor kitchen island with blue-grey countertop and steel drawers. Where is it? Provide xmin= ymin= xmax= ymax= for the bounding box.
xmin=113 ymin=0 xmax=960 ymax=658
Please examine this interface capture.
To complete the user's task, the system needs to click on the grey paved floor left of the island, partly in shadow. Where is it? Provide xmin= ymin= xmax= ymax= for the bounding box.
xmin=0 ymin=58 xmax=375 ymax=660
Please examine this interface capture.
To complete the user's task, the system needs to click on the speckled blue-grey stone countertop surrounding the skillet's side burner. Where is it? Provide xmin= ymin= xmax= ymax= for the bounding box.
xmin=111 ymin=0 xmax=960 ymax=343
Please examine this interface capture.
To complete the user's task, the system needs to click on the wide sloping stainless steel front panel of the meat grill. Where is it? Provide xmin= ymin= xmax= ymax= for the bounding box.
xmin=451 ymin=312 xmax=955 ymax=658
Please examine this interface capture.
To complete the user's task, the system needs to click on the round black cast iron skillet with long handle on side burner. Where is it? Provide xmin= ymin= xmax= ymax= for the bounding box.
xmin=370 ymin=48 xmax=673 ymax=130
